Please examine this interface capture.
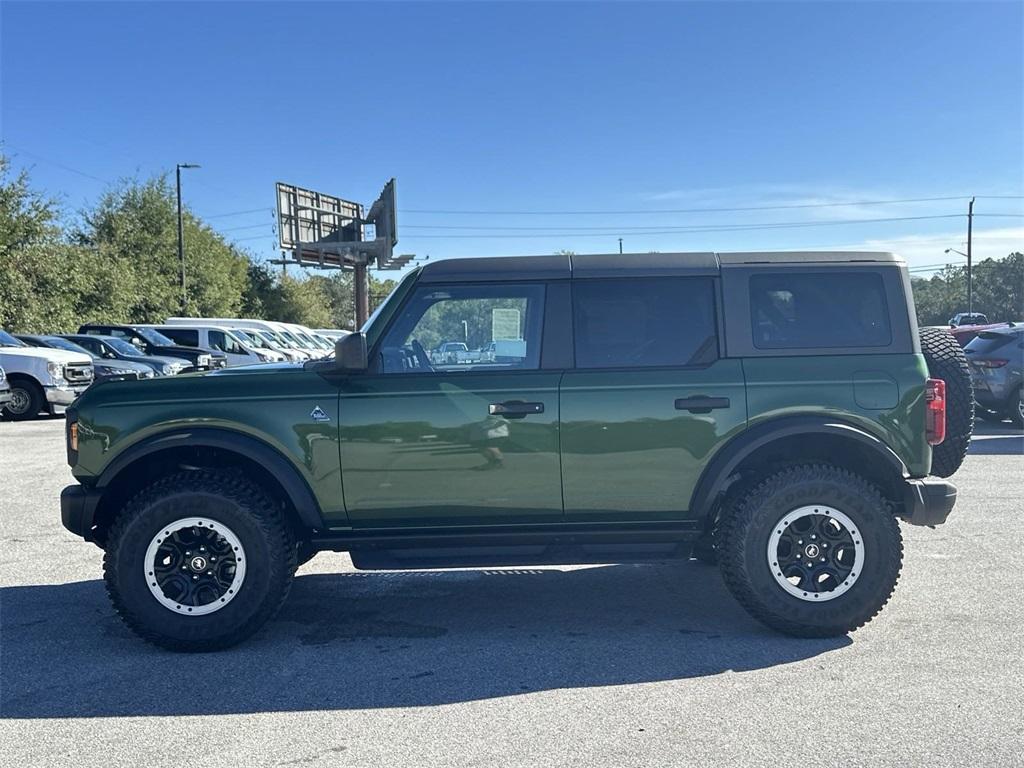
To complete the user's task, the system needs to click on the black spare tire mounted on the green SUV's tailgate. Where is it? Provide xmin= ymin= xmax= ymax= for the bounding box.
xmin=921 ymin=328 xmax=974 ymax=477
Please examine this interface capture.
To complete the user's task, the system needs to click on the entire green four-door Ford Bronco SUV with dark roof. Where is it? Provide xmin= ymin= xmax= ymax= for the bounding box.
xmin=61 ymin=253 xmax=973 ymax=650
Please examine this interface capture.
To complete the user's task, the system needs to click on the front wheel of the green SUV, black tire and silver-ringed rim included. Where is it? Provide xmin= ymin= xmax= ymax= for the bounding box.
xmin=103 ymin=470 xmax=295 ymax=651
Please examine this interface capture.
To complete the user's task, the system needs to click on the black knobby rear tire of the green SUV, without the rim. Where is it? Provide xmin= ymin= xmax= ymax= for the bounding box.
xmin=717 ymin=464 xmax=903 ymax=637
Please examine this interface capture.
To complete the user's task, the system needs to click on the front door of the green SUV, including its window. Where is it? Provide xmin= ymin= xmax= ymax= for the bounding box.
xmin=339 ymin=283 xmax=562 ymax=526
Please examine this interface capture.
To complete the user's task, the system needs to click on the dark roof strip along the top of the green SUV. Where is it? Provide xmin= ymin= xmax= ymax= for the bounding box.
xmin=419 ymin=251 xmax=903 ymax=283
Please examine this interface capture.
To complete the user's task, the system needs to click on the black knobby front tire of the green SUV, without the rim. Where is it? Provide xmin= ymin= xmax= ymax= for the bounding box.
xmin=103 ymin=470 xmax=296 ymax=651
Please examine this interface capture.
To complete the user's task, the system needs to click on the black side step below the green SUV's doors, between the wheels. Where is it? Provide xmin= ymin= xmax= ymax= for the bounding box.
xmin=349 ymin=542 xmax=692 ymax=570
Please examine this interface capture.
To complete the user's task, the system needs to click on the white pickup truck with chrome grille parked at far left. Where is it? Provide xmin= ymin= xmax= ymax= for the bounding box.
xmin=0 ymin=331 xmax=93 ymax=421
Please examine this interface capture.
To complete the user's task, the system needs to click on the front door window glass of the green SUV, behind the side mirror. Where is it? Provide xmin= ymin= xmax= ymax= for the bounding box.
xmin=381 ymin=285 xmax=544 ymax=373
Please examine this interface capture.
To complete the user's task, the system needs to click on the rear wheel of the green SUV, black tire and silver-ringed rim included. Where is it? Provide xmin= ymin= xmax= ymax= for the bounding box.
xmin=717 ymin=465 xmax=903 ymax=637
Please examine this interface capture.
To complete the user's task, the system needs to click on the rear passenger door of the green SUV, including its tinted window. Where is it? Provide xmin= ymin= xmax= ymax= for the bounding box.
xmin=560 ymin=276 xmax=746 ymax=521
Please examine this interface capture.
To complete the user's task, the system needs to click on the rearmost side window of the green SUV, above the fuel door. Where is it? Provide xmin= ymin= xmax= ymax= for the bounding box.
xmin=751 ymin=272 xmax=892 ymax=349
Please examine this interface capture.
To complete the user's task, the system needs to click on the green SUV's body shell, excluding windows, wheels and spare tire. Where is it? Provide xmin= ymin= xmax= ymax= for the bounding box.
xmin=62 ymin=254 xmax=951 ymax=561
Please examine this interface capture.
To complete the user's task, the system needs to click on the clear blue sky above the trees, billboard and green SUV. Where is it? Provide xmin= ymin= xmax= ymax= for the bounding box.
xmin=0 ymin=2 xmax=1024 ymax=274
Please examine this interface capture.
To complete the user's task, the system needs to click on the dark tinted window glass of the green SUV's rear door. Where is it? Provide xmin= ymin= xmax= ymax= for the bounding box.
xmin=572 ymin=278 xmax=718 ymax=368
